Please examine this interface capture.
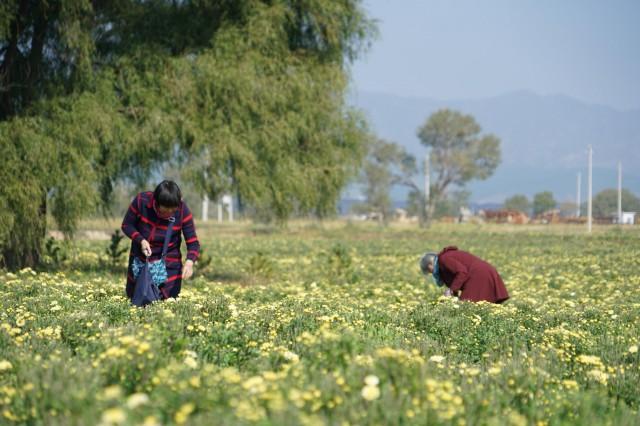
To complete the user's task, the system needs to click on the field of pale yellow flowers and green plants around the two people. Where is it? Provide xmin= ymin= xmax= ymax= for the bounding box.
xmin=0 ymin=225 xmax=640 ymax=425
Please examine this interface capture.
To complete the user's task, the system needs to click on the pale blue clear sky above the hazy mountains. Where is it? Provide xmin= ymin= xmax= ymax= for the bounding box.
xmin=351 ymin=0 xmax=640 ymax=110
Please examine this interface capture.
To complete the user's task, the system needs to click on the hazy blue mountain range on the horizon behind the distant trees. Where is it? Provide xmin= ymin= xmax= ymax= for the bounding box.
xmin=351 ymin=91 xmax=640 ymax=202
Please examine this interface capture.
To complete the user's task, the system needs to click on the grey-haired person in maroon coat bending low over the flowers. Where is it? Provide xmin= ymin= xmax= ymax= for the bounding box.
xmin=420 ymin=246 xmax=509 ymax=303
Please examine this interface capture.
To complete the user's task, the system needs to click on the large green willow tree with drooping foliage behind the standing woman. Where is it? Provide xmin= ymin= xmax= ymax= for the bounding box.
xmin=0 ymin=0 xmax=373 ymax=268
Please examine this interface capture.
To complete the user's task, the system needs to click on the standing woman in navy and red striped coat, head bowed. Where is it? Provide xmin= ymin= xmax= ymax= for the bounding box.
xmin=122 ymin=180 xmax=200 ymax=299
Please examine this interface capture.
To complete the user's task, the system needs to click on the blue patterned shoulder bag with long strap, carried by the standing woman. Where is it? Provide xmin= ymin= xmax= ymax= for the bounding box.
xmin=131 ymin=216 xmax=176 ymax=306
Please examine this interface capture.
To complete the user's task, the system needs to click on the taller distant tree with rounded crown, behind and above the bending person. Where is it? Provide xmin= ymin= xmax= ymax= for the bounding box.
xmin=418 ymin=109 xmax=500 ymax=223
